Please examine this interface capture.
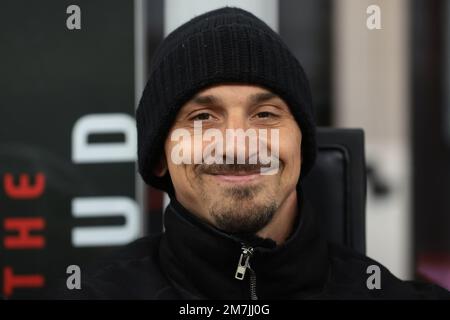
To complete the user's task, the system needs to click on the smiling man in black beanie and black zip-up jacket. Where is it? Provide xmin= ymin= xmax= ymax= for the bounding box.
xmin=66 ymin=8 xmax=449 ymax=299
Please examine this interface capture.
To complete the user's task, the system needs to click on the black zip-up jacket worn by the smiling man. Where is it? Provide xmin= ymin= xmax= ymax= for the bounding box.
xmin=58 ymin=189 xmax=450 ymax=299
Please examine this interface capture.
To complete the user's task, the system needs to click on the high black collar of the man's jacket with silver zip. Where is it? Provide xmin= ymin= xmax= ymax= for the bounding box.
xmin=160 ymin=186 xmax=329 ymax=299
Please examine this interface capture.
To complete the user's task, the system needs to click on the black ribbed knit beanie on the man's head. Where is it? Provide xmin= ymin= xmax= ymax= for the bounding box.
xmin=136 ymin=7 xmax=316 ymax=194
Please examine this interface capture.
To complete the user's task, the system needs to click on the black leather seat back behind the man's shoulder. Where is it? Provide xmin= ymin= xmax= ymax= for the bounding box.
xmin=303 ymin=127 xmax=366 ymax=253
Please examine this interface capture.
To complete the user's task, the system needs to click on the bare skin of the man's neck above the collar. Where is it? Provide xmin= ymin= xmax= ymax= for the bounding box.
xmin=257 ymin=189 xmax=298 ymax=245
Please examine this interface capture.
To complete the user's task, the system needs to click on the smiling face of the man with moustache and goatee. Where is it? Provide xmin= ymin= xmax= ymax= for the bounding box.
xmin=160 ymin=84 xmax=302 ymax=233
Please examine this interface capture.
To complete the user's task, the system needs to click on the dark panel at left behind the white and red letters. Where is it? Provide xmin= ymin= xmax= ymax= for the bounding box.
xmin=0 ymin=0 xmax=135 ymax=298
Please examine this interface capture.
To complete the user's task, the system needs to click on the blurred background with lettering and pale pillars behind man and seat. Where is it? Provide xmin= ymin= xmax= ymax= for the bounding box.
xmin=0 ymin=0 xmax=450 ymax=299
